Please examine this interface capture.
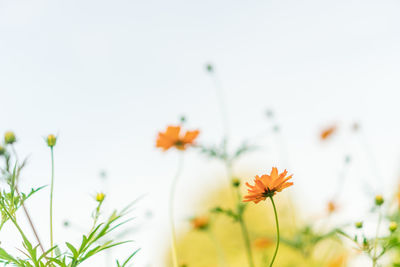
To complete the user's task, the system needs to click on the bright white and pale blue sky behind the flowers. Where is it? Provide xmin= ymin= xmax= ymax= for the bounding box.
xmin=0 ymin=0 xmax=400 ymax=267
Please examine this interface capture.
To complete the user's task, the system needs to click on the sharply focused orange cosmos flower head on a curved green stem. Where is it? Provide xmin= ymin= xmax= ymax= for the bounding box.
xmin=243 ymin=167 xmax=293 ymax=203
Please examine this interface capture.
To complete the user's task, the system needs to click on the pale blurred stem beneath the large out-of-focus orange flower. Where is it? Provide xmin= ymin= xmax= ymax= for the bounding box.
xmin=169 ymin=153 xmax=183 ymax=267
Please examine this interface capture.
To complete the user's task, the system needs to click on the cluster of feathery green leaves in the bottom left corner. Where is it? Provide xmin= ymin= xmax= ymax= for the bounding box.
xmin=0 ymin=137 xmax=139 ymax=267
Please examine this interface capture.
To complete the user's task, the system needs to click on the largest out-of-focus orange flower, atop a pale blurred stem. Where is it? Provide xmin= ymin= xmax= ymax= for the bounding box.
xmin=156 ymin=126 xmax=200 ymax=151
